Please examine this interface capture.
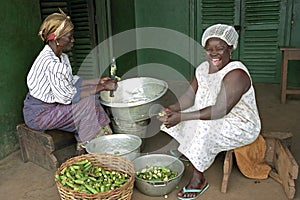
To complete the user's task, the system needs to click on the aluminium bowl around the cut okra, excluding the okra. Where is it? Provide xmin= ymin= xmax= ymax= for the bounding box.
xmin=133 ymin=154 xmax=184 ymax=196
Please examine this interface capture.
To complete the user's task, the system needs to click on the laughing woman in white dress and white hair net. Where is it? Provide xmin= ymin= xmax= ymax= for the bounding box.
xmin=158 ymin=24 xmax=261 ymax=199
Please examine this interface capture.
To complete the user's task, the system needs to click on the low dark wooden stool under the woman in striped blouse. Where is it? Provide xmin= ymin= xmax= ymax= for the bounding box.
xmin=16 ymin=124 xmax=76 ymax=170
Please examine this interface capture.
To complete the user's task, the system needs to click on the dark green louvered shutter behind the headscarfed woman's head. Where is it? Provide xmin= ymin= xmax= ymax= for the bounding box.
xmin=40 ymin=0 xmax=100 ymax=78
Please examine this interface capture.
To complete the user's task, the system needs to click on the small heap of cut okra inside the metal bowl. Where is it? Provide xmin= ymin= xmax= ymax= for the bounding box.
xmin=136 ymin=166 xmax=177 ymax=181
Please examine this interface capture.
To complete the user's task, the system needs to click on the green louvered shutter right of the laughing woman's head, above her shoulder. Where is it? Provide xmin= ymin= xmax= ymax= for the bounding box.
xmin=240 ymin=0 xmax=280 ymax=82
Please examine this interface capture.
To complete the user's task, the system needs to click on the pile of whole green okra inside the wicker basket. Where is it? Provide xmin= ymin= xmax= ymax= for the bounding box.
xmin=55 ymin=159 xmax=130 ymax=194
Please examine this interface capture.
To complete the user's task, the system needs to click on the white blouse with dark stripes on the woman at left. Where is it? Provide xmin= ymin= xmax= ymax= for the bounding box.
xmin=27 ymin=45 xmax=82 ymax=104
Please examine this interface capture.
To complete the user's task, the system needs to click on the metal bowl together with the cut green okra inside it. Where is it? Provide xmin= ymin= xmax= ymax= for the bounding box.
xmin=133 ymin=154 xmax=184 ymax=196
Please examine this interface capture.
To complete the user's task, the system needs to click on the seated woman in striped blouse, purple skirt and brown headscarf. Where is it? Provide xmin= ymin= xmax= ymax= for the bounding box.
xmin=23 ymin=9 xmax=116 ymax=155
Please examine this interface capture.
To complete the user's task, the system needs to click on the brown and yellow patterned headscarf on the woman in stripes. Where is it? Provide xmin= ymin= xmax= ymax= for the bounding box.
xmin=38 ymin=8 xmax=74 ymax=42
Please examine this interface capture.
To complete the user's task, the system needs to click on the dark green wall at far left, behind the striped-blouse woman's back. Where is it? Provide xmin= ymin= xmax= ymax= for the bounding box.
xmin=0 ymin=0 xmax=42 ymax=159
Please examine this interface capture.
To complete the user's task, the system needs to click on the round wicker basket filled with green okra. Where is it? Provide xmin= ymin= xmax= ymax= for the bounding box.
xmin=55 ymin=154 xmax=135 ymax=200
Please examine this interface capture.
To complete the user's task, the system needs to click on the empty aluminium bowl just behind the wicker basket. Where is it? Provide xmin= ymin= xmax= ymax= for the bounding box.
xmin=86 ymin=134 xmax=142 ymax=161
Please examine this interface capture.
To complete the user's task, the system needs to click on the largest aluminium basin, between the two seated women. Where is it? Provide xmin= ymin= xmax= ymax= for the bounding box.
xmin=100 ymin=77 xmax=168 ymax=122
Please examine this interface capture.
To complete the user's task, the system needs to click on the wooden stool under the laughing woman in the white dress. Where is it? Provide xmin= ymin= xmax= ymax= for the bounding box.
xmin=221 ymin=132 xmax=299 ymax=199
